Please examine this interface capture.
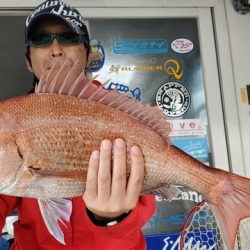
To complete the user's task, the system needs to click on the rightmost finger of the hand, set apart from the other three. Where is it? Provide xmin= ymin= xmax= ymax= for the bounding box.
xmin=126 ymin=146 xmax=145 ymax=205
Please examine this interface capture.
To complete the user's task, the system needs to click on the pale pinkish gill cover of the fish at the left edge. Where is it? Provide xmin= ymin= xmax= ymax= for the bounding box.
xmin=0 ymin=134 xmax=24 ymax=193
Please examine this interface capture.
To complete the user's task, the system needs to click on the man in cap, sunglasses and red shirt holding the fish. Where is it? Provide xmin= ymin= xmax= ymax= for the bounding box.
xmin=0 ymin=1 xmax=155 ymax=250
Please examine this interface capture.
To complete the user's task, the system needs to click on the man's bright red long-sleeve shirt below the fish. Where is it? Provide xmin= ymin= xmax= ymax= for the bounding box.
xmin=0 ymin=195 xmax=155 ymax=250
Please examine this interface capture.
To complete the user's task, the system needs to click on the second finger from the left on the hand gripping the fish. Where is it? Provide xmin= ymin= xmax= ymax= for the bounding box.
xmin=98 ymin=140 xmax=112 ymax=200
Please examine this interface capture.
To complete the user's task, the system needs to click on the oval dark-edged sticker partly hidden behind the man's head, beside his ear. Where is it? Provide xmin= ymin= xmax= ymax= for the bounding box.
xmin=87 ymin=39 xmax=105 ymax=72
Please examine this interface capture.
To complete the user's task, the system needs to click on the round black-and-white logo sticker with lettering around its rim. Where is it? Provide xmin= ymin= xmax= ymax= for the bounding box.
xmin=155 ymin=82 xmax=191 ymax=117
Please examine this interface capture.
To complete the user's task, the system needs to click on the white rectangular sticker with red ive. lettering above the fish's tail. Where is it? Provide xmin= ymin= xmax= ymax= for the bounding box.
xmin=168 ymin=119 xmax=206 ymax=136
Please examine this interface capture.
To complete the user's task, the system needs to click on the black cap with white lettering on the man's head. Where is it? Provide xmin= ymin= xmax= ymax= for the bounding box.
xmin=25 ymin=0 xmax=89 ymax=45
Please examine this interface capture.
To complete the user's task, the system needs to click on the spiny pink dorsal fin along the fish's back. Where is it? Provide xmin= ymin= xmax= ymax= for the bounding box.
xmin=35 ymin=61 xmax=171 ymax=138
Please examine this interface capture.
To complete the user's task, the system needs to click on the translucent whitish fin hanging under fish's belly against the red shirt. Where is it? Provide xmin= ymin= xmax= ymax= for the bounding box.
xmin=38 ymin=198 xmax=72 ymax=245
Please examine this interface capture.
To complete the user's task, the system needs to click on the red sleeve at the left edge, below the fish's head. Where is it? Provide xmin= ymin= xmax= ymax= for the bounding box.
xmin=0 ymin=194 xmax=19 ymax=232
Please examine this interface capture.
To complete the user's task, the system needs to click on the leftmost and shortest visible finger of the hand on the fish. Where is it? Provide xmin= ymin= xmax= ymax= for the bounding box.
xmin=85 ymin=150 xmax=99 ymax=198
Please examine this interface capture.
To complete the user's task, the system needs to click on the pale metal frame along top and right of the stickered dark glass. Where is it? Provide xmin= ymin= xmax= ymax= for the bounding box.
xmin=0 ymin=0 xmax=246 ymax=175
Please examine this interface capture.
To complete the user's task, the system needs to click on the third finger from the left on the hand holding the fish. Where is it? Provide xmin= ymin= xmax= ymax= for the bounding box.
xmin=111 ymin=138 xmax=127 ymax=200
